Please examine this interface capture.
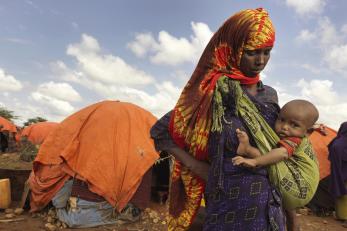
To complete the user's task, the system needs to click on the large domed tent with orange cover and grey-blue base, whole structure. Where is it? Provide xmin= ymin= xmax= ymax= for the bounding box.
xmin=29 ymin=101 xmax=159 ymax=228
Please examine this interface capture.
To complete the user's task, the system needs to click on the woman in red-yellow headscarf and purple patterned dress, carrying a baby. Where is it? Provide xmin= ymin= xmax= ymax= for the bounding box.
xmin=151 ymin=8 xmax=284 ymax=230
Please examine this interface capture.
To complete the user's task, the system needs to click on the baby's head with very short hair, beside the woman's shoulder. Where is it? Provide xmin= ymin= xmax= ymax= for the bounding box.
xmin=275 ymin=99 xmax=319 ymax=138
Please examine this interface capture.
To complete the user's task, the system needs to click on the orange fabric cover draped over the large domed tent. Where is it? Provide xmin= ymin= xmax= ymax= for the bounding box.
xmin=29 ymin=101 xmax=159 ymax=211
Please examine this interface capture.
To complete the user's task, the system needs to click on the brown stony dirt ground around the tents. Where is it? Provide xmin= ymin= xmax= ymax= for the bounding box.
xmin=0 ymin=154 xmax=347 ymax=231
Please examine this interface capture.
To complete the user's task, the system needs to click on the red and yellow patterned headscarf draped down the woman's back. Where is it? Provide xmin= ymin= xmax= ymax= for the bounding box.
xmin=169 ymin=8 xmax=275 ymax=230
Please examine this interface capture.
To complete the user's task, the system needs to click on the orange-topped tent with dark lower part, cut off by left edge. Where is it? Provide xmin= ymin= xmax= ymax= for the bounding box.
xmin=0 ymin=116 xmax=17 ymax=152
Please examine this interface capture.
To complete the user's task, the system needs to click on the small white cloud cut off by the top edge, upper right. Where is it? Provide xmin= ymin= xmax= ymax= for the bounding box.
xmin=286 ymin=0 xmax=326 ymax=16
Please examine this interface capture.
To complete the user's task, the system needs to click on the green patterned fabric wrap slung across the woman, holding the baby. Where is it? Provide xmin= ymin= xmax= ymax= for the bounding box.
xmin=230 ymin=81 xmax=319 ymax=209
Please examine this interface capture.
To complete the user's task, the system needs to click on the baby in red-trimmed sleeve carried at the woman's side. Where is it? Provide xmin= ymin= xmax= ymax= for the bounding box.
xmin=232 ymin=100 xmax=319 ymax=167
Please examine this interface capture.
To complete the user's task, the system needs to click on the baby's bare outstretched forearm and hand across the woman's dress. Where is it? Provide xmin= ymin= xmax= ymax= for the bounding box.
xmin=232 ymin=147 xmax=289 ymax=167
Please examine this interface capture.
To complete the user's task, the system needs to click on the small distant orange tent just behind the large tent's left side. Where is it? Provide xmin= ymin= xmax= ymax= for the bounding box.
xmin=21 ymin=122 xmax=58 ymax=144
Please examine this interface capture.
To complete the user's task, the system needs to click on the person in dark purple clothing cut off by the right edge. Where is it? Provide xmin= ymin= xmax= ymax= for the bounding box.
xmin=328 ymin=122 xmax=347 ymax=227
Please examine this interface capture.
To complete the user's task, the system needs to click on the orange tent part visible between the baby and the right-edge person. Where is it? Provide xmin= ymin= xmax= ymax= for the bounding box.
xmin=309 ymin=125 xmax=337 ymax=179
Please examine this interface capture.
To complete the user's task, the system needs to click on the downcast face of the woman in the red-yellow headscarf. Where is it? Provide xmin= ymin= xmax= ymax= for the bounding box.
xmin=240 ymin=47 xmax=272 ymax=77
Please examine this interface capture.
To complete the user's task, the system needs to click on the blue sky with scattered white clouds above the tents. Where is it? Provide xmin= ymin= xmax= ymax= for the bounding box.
xmin=0 ymin=0 xmax=347 ymax=129
